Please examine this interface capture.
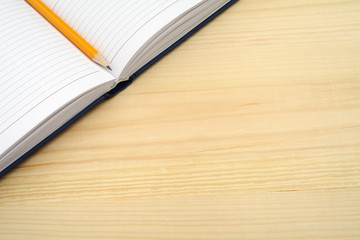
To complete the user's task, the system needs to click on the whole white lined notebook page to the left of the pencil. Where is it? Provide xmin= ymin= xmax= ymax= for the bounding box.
xmin=0 ymin=0 xmax=113 ymax=157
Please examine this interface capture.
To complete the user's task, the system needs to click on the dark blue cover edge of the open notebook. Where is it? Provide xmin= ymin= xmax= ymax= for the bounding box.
xmin=0 ymin=0 xmax=238 ymax=177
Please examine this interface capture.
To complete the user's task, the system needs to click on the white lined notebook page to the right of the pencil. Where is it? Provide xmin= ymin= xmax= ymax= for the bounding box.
xmin=43 ymin=0 xmax=203 ymax=76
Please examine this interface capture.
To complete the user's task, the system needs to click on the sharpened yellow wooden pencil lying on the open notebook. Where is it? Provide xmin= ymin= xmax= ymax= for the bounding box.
xmin=26 ymin=0 xmax=111 ymax=70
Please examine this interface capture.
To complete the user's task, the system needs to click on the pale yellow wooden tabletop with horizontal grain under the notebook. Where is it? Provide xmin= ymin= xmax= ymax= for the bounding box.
xmin=0 ymin=0 xmax=360 ymax=240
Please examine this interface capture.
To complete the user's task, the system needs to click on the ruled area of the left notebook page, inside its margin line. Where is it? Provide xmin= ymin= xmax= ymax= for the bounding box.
xmin=0 ymin=0 xmax=98 ymax=134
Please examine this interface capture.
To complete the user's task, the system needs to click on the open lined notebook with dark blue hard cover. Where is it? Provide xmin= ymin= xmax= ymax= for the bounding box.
xmin=0 ymin=0 xmax=236 ymax=175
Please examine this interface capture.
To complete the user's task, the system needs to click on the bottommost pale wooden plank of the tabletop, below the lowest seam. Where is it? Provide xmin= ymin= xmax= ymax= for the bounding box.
xmin=0 ymin=188 xmax=360 ymax=240
